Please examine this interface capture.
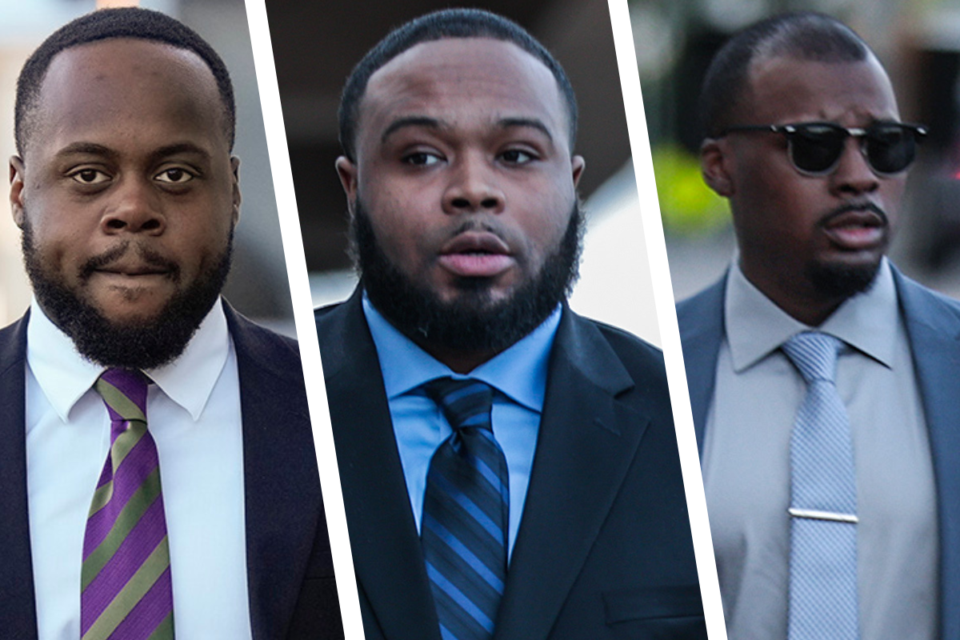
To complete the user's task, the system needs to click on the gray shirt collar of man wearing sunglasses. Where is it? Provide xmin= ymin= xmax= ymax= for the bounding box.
xmin=724 ymin=258 xmax=900 ymax=373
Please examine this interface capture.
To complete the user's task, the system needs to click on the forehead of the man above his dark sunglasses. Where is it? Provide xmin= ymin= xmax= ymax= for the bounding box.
xmin=744 ymin=55 xmax=900 ymax=126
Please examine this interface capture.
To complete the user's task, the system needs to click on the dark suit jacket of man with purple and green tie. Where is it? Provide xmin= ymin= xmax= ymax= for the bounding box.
xmin=0 ymin=305 xmax=343 ymax=640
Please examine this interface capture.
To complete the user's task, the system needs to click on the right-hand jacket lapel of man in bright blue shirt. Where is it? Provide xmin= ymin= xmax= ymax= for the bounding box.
xmin=496 ymin=309 xmax=648 ymax=640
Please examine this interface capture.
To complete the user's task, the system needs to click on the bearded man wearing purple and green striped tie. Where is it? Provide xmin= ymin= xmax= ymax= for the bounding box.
xmin=0 ymin=9 xmax=343 ymax=640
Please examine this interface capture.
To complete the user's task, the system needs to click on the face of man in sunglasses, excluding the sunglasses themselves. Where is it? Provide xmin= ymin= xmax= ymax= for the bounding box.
xmin=702 ymin=55 xmax=906 ymax=325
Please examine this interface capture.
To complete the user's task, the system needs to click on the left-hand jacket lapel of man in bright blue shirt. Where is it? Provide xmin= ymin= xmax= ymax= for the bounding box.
xmin=321 ymin=291 xmax=440 ymax=640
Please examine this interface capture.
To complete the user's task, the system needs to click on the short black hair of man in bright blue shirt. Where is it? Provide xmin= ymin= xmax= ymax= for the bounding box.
xmin=339 ymin=9 xmax=577 ymax=161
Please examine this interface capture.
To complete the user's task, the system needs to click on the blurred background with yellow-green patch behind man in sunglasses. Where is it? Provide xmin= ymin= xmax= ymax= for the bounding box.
xmin=629 ymin=0 xmax=960 ymax=300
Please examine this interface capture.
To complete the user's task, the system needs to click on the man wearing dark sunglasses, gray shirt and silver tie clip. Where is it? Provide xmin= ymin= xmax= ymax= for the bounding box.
xmin=678 ymin=13 xmax=960 ymax=640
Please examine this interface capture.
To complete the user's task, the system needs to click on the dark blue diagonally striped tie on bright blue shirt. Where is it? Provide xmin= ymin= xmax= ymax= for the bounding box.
xmin=420 ymin=378 xmax=510 ymax=640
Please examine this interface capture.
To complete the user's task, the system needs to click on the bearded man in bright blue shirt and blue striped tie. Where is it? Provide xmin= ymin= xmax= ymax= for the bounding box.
xmin=316 ymin=10 xmax=706 ymax=640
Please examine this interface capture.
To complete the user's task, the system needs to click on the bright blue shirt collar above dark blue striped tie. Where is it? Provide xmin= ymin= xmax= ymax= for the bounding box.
xmin=363 ymin=293 xmax=562 ymax=412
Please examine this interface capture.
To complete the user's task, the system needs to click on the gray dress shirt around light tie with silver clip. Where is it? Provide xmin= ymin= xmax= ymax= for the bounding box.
xmin=703 ymin=261 xmax=939 ymax=640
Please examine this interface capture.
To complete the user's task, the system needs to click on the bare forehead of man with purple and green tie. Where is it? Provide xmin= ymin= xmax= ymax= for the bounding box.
xmin=27 ymin=38 xmax=227 ymax=155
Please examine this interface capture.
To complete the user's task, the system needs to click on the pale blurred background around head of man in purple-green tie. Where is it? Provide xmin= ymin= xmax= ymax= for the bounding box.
xmin=0 ymin=0 xmax=294 ymax=335
